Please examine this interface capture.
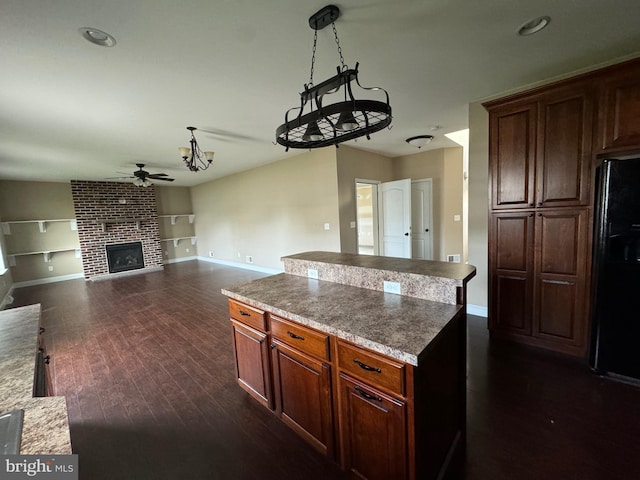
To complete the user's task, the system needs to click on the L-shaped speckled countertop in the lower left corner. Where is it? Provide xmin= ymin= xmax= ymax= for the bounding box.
xmin=0 ymin=304 xmax=71 ymax=455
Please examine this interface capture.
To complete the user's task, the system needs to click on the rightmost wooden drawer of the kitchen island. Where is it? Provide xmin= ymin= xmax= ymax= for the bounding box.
xmin=338 ymin=340 xmax=405 ymax=396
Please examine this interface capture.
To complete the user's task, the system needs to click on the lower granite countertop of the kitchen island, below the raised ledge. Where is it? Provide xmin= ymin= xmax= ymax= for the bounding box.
xmin=222 ymin=273 xmax=463 ymax=366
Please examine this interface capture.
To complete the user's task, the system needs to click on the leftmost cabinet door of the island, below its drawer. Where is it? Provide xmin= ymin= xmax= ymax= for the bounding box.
xmin=231 ymin=320 xmax=273 ymax=409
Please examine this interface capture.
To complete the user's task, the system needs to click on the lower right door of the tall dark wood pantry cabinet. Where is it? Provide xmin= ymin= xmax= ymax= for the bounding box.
xmin=534 ymin=209 xmax=589 ymax=355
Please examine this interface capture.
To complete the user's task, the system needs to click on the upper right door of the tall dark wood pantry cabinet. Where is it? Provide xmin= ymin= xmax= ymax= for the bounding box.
xmin=536 ymin=85 xmax=595 ymax=207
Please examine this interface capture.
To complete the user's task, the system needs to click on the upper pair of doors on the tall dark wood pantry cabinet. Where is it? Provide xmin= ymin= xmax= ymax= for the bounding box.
xmin=488 ymin=84 xmax=595 ymax=210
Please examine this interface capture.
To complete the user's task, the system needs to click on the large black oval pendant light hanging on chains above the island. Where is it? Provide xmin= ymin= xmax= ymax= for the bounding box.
xmin=276 ymin=5 xmax=391 ymax=151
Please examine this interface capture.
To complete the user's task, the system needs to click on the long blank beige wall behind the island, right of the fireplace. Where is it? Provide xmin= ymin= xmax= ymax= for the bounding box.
xmin=191 ymin=147 xmax=340 ymax=270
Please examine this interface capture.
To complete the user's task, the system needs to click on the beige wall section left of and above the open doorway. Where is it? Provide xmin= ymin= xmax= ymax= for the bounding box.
xmin=336 ymin=145 xmax=394 ymax=253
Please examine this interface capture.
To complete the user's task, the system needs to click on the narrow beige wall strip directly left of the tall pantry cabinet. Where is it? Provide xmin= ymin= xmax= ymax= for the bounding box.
xmin=468 ymin=103 xmax=489 ymax=307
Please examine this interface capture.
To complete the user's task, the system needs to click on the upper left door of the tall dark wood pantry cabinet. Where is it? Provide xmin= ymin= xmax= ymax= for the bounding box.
xmin=489 ymin=103 xmax=537 ymax=209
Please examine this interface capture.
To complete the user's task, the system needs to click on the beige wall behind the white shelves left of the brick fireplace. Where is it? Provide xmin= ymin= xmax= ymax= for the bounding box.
xmin=0 ymin=181 xmax=82 ymax=282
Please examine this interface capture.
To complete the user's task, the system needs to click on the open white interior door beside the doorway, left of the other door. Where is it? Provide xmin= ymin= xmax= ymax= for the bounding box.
xmin=378 ymin=178 xmax=411 ymax=258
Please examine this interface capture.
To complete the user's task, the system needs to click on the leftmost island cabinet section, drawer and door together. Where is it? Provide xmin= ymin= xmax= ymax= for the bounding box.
xmin=229 ymin=300 xmax=273 ymax=409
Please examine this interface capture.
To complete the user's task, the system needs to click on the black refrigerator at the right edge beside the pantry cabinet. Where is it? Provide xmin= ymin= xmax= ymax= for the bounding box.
xmin=589 ymin=158 xmax=640 ymax=383
